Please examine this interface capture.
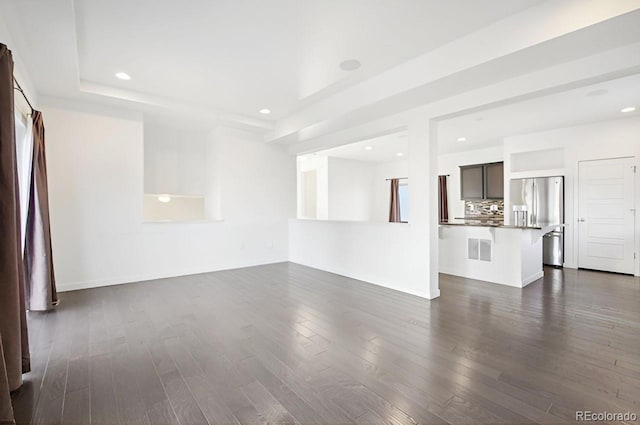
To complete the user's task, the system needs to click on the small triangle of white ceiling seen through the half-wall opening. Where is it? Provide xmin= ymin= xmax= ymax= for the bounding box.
xmin=310 ymin=131 xmax=409 ymax=162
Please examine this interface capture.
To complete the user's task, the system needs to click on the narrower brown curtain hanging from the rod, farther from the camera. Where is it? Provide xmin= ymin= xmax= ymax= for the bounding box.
xmin=24 ymin=111 xmax=58 ymax=311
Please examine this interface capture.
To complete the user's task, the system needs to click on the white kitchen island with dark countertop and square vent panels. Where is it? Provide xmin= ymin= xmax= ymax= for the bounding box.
xmin=439 ymin=220 xmax=562 ymax=288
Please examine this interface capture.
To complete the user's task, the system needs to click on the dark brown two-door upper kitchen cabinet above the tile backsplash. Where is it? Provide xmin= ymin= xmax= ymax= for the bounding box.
xmin=460 ymin=162 xmax=504 ymax=200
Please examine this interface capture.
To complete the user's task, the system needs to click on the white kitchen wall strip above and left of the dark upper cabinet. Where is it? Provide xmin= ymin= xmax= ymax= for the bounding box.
xmin=438 ymin=146 xmax=504 ymax=219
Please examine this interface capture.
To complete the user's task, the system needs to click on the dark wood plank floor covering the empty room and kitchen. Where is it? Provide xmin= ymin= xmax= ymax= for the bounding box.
xmin=14 ymin=263 xmax=640 ymax=425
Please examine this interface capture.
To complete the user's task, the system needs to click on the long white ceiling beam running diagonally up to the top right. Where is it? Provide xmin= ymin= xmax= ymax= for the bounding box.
xmin=265 ymin=0 xmax=640 ymax=144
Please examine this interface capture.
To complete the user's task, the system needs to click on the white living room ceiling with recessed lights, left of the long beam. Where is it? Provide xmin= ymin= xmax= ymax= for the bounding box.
xmin=0 ymin=0 xmax=541 ymax=120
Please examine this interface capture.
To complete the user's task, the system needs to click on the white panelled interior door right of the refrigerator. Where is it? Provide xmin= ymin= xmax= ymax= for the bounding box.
xmin=578 ymin=158 xmax=635 ymax=274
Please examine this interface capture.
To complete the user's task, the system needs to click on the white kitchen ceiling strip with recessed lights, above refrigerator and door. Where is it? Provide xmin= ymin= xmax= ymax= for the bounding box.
xmin=438 ymin=74 xmax=640 ymax=153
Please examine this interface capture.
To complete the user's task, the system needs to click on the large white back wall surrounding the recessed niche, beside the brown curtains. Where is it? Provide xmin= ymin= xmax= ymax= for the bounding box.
xmin=44 ymin=107 xmax=295 ymax=291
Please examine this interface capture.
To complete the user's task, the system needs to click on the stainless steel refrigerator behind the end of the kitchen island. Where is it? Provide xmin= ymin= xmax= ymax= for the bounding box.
xmin=509 ymin=177 xmax=564 ymax=267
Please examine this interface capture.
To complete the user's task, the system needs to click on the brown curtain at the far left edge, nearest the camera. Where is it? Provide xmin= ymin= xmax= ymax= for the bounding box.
xmin=0 ymin=44 xmax=30 ymax=423
